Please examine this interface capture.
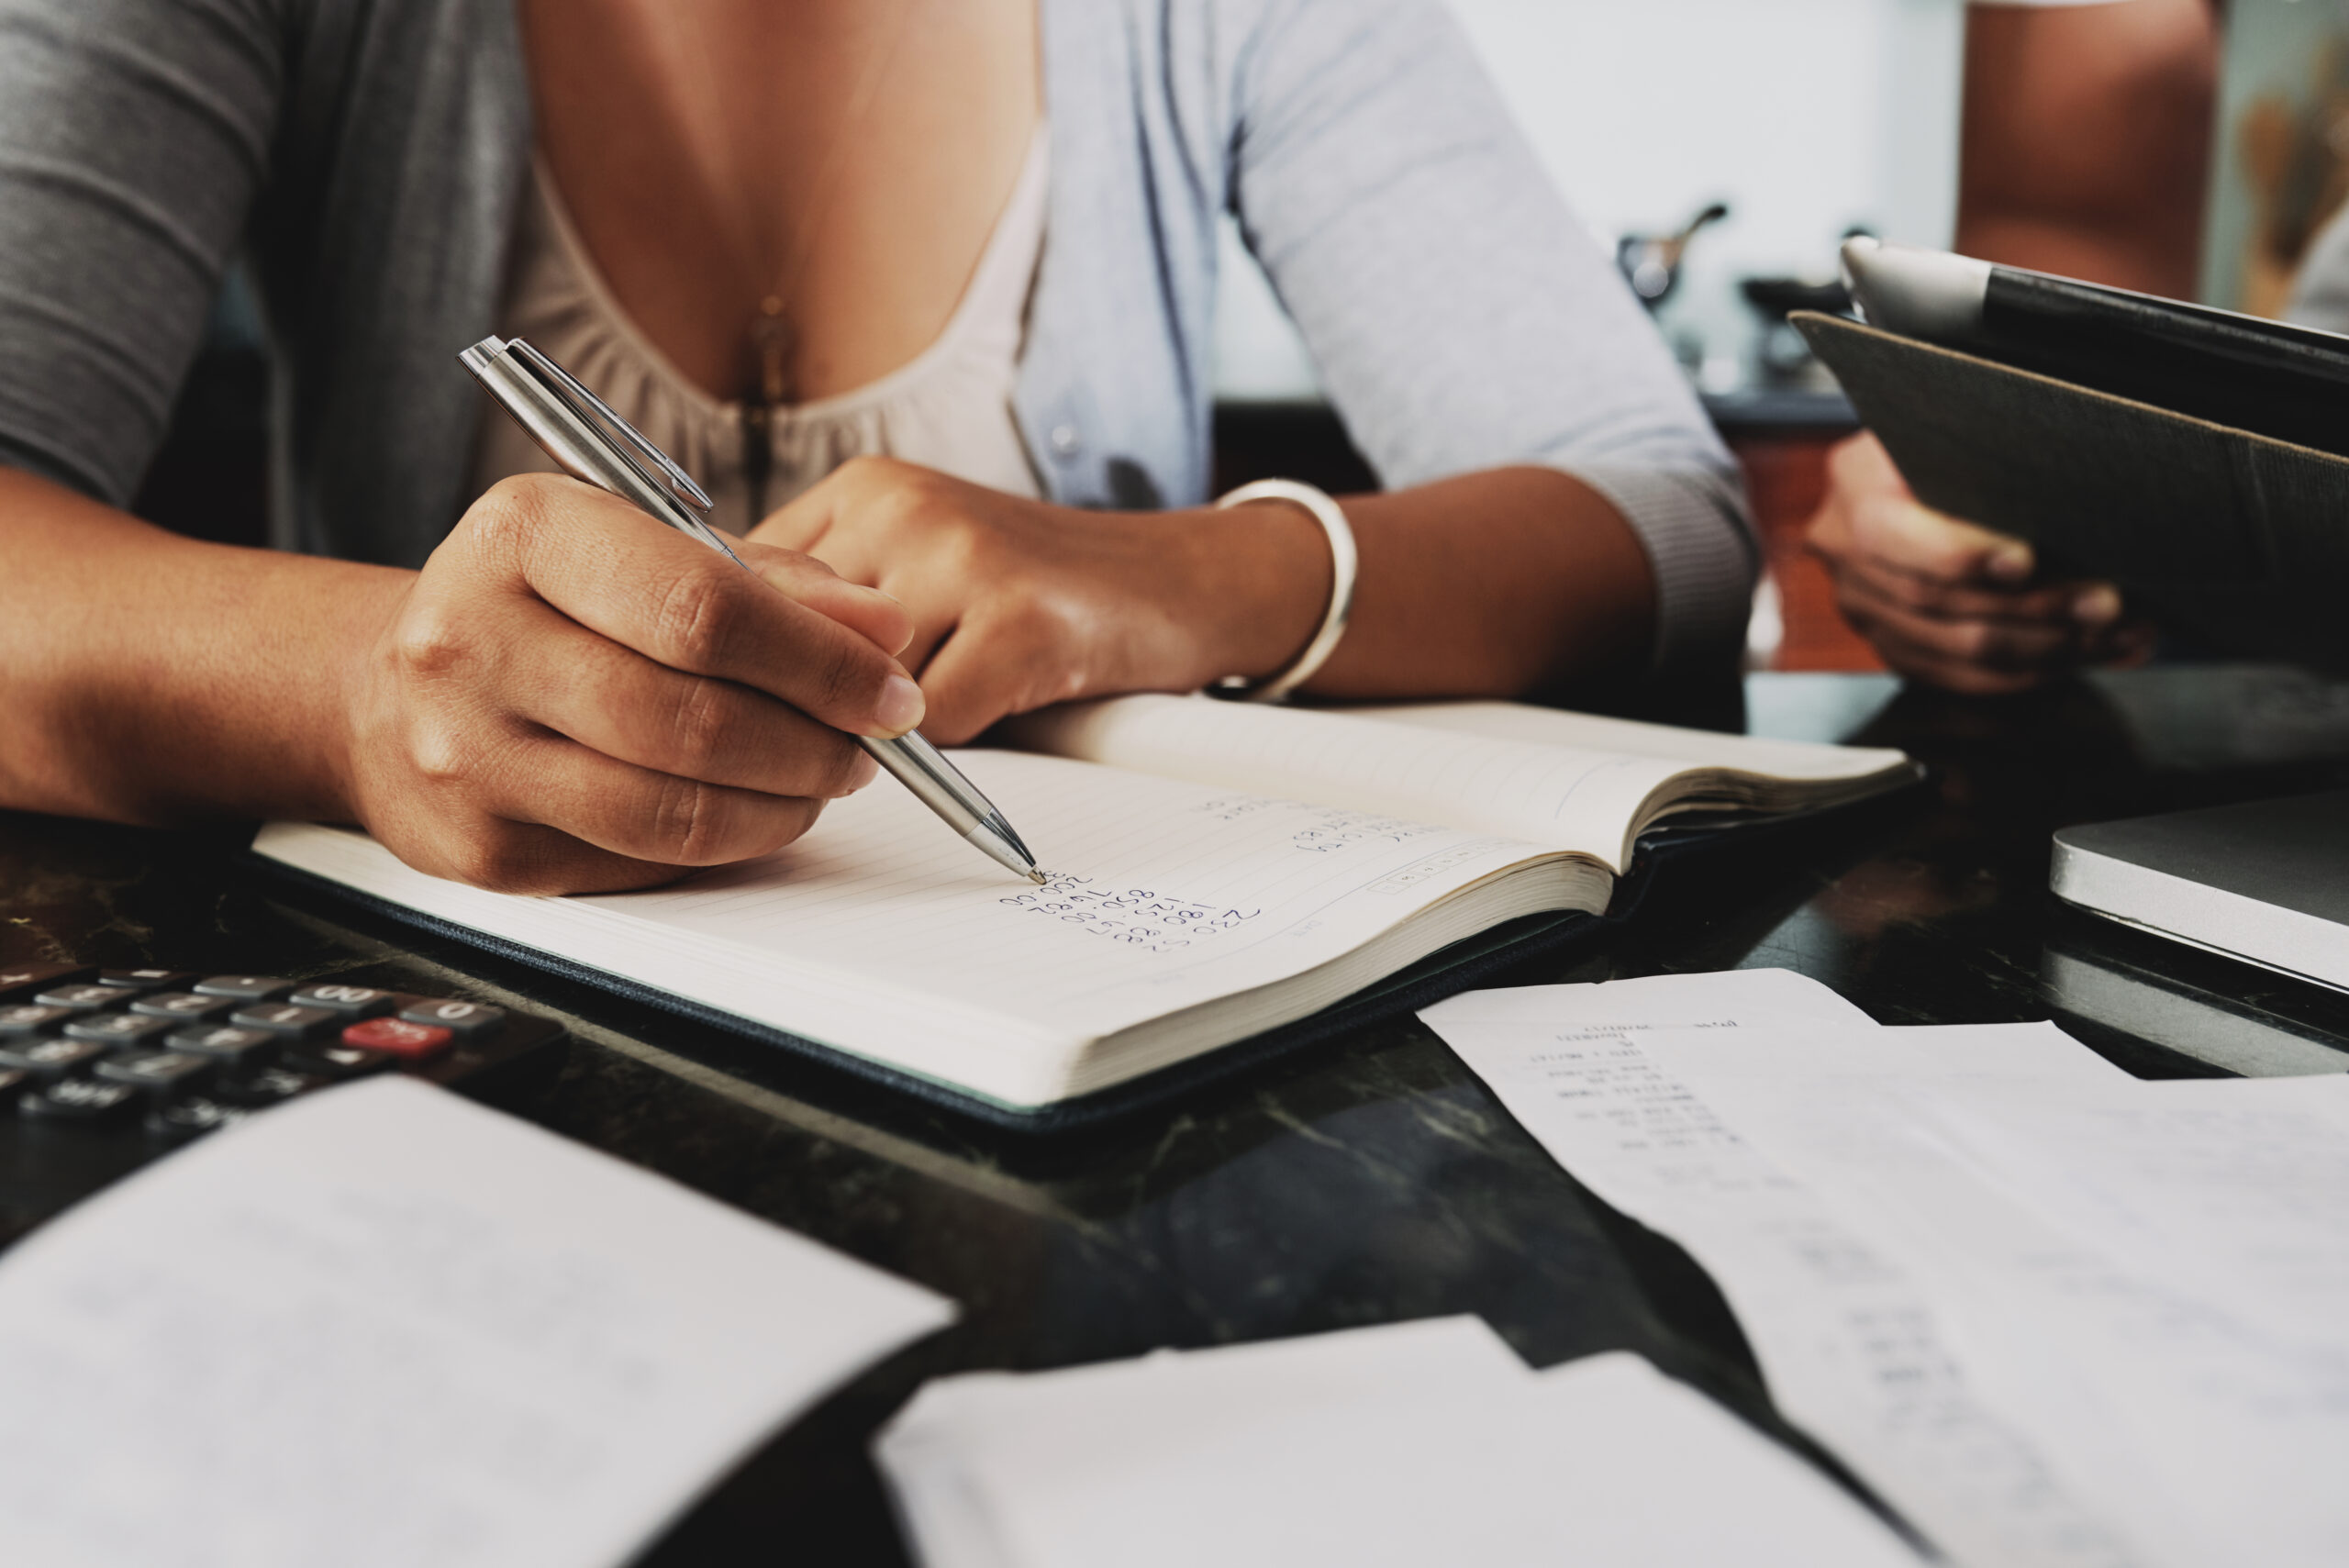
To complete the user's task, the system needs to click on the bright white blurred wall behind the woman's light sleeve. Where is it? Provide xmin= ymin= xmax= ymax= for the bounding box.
xmin=1217 ymin=0 xmax=1966 ymax=410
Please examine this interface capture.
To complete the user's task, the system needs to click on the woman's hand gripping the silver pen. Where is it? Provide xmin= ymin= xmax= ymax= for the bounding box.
xmin=343 ymin=476 xmax=923 ymax=892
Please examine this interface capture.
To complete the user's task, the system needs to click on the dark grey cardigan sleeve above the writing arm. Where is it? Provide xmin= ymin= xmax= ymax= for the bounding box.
xmin=0 ymin=0 xmax=284 ymax=505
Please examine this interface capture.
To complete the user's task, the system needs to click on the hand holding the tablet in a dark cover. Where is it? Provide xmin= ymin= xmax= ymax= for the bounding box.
xmin=1807 ymin=432 xmax=2152 ymax=693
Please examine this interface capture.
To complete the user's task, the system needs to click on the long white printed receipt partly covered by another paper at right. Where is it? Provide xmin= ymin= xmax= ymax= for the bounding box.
xmin=1421 ymin=970 xmax=2156 ymax=1568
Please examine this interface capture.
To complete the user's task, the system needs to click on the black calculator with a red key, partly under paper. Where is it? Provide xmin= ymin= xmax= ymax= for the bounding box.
xmin=0 ymin=964 xmax=566 ymax=1247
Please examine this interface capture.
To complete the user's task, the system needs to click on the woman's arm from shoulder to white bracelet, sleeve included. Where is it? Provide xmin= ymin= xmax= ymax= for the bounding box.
xmin=1229 ymin=0 xmax=1757 ymax=695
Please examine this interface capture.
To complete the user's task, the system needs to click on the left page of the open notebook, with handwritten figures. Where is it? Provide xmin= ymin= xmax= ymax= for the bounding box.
xmin=256 ymin=751 xmax=1578 ymax=1103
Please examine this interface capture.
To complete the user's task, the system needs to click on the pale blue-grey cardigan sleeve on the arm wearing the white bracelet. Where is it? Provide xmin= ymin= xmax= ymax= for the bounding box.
xmin=1226 ymin=0 xmax=1757 ymax=678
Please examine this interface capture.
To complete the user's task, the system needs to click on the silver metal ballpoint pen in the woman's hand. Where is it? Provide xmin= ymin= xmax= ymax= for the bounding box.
xmin=458 ymin=338 xmax=1045 ymax=883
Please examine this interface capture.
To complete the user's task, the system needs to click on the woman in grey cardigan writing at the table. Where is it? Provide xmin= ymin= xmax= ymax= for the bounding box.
xmin=0 ymin=0 xmax=1754 ymax=892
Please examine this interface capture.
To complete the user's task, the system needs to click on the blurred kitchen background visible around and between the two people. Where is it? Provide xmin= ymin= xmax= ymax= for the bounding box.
xmin=139 ymin=0 xmax=2349 ymax=669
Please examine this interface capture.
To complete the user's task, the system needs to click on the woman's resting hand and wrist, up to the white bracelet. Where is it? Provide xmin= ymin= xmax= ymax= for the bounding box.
xmin=750 ymin=458 xmax=1330 ymax=744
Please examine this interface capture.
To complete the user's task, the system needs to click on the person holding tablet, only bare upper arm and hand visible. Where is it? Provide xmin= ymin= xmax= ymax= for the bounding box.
xmin=1807 ymin=0 xmax=2218 ymax=693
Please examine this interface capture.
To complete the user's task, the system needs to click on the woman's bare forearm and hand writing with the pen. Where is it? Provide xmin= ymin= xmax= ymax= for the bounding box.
xmin=0 ymin=470 xmax=921 ymax=892
